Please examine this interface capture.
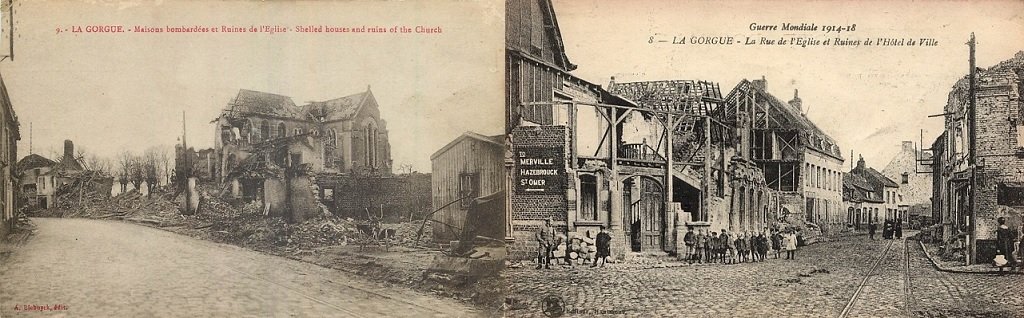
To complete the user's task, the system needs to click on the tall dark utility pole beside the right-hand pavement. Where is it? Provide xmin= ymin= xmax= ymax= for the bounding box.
xmin=967 ymin=32 xmax=978 ymax=264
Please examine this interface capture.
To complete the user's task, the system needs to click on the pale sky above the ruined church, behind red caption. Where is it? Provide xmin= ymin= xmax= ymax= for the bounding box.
xmin=0 ymin=1 xmax=504 ymax=172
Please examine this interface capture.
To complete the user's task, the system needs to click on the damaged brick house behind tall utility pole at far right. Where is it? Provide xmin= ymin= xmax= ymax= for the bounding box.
xmin=929 ymin=52 xmax=1024 ymax=264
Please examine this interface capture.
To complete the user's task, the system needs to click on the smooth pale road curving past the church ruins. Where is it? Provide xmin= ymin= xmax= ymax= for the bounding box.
xmin=0 ymin=219 xmax=475 ymax=317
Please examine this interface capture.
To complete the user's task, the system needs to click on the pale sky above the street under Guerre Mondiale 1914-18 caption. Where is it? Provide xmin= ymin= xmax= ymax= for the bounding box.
xmin=554 ymin=0 xmax=1024 ymax=170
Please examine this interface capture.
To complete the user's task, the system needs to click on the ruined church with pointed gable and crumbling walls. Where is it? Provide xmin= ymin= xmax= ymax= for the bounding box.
xmin=214 ymin=87 xmax=430 ymax=221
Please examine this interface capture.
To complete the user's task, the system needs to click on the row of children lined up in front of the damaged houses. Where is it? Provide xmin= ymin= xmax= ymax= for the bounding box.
xmin=683 ymin=229 xmax=797 ymax=264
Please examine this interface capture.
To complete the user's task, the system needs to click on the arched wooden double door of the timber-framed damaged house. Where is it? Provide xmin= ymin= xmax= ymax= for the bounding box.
xmin=623 ymin=176 xmax=666 ymax=252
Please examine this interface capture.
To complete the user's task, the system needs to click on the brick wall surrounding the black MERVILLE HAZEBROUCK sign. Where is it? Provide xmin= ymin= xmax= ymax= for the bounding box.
xmin=507 ymin=126 xmax=573 ymax=260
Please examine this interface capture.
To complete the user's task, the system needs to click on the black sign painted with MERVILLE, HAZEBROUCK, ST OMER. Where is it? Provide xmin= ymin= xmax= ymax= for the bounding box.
xmin=515 ymin=147 xmax=565 ymax=194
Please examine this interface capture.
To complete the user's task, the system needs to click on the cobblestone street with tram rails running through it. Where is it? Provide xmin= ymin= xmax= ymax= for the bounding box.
xmin=504 ymin=233 xmax=1024 ymax=317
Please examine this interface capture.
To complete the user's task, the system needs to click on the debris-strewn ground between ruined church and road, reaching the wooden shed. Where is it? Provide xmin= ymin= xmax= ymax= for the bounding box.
xmin=22 ymin=185 xmax=504 ymax=307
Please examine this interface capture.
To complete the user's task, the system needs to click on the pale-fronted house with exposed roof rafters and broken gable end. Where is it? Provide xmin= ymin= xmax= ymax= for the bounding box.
xmin=726 ymin=81 xmax=847 ymax=237
